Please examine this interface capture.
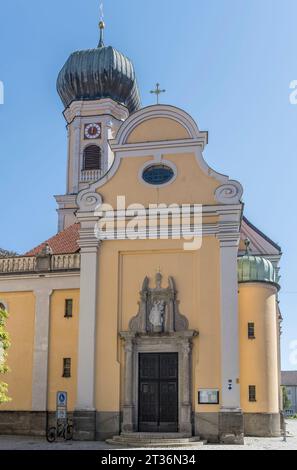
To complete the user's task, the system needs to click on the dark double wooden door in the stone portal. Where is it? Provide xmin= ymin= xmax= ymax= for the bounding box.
xmin=138 ymin=353 xmax=178 ymax=432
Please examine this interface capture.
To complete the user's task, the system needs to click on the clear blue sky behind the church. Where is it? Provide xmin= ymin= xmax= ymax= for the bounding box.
xmin=0 ymin=0 xmax=297 ymax=369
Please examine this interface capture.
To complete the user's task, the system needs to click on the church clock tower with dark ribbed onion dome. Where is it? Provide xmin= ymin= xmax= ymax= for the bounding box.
xmin=56 ymin=21 xmax=140 ymax=232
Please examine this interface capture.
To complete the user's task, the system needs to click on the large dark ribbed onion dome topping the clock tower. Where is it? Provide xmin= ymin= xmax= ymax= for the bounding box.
xmin=57 ymin=21 xmax=140 ymax=112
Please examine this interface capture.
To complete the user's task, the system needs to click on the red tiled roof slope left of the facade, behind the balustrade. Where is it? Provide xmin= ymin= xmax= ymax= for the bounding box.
xmin=24 ymin=224 xmax=80 ymax=256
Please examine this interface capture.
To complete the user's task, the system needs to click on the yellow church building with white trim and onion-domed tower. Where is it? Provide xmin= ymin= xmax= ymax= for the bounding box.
xmin=0 ymin=23 xmax=281 ymax=443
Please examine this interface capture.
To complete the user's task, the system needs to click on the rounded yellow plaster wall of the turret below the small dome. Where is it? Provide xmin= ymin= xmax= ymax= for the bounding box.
xmin=239 ymin=283 xmax=279 ymax=413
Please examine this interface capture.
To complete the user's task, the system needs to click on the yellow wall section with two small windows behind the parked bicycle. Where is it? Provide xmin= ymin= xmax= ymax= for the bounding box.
xmin=48 ymin=289 xmax=79 ymax=411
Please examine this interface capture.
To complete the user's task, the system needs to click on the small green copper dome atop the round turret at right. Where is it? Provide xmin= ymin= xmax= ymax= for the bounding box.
xmin=237 ymin=239 xmax=279 ymax=287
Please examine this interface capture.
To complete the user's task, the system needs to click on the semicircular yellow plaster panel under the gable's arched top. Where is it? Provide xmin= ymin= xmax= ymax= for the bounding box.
xmin=127 ymin=118 xmax=190 ymax=144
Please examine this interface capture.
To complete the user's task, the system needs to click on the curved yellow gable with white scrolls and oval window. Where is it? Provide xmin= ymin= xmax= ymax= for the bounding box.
xmin=77 ymin=105 xmax=243 ymax=210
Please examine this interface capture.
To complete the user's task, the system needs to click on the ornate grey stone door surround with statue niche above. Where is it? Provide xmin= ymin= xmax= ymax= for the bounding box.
xmin=120 ymin=273 xmax=198 ymax=436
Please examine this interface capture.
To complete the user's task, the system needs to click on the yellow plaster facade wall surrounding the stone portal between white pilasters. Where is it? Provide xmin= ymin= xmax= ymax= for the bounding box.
xmin=96 ymin=237 xmax=220 ymax=411
